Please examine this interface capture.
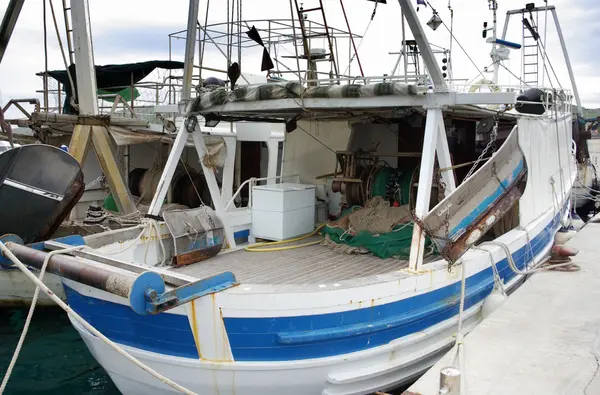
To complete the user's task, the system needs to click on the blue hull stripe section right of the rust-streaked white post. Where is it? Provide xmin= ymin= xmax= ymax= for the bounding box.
xmin=224 ymin=216 xmax=558 ymax=361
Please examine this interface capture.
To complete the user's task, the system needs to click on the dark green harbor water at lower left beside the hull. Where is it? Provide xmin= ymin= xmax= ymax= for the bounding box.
xmin=0 ymin=307 xmax=119 ymax=395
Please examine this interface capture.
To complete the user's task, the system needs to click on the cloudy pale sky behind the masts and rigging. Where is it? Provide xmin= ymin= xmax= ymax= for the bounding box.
xmin=0 ymin=0 xmax=600 ymax=115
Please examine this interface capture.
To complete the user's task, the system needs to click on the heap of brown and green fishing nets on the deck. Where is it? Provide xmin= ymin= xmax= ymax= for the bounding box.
xmin=321 ymin=196 xmax=432 ymax=259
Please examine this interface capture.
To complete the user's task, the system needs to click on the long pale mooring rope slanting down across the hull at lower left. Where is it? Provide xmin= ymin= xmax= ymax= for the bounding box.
xmin=0 ymin=241 xmax=197 ymax=395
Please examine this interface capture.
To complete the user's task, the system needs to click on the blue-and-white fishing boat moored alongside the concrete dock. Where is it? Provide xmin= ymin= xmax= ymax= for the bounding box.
xmin=3 ymin=0 xmax=581 ymax=395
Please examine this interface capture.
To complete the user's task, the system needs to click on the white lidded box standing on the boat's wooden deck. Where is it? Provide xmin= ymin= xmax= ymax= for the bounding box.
xmin=252 ymin=183 xmax=315 ymax=241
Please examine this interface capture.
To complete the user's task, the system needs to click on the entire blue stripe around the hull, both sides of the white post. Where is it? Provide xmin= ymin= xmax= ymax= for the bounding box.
xmin=65 ymin=212 xmax=559 ymax=361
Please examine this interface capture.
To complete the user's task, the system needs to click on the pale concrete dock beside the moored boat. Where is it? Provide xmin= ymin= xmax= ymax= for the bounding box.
xmin=405 ymin=223 xmax=600 ymax=395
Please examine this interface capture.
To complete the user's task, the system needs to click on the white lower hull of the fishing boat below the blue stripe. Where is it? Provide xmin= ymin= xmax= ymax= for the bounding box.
xmin=71 ymin=304 xmax=481 ymax=395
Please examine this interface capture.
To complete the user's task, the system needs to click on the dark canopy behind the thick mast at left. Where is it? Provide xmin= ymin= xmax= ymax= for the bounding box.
xmin=48 ymin=60 xmax=183 ymax=114
